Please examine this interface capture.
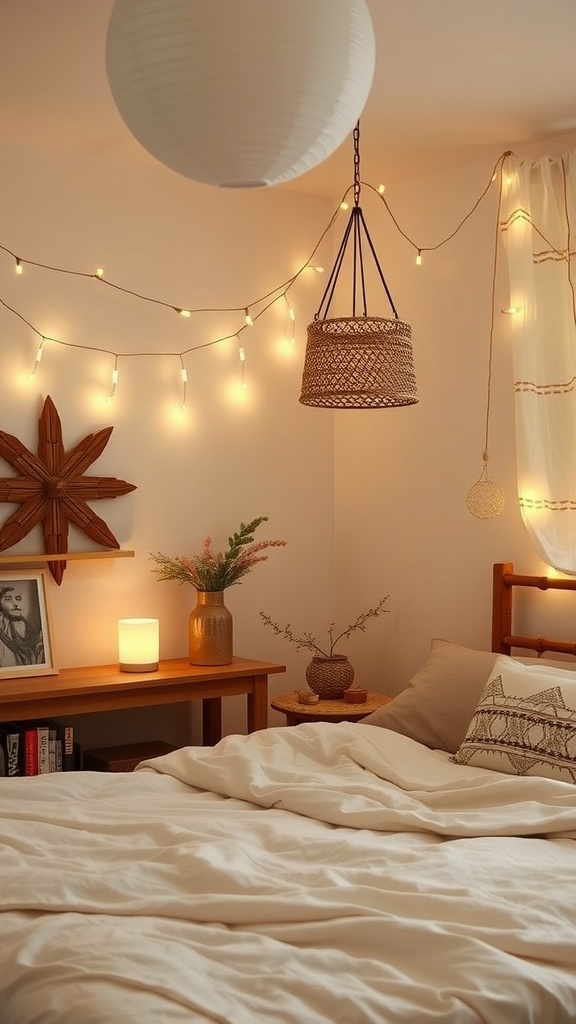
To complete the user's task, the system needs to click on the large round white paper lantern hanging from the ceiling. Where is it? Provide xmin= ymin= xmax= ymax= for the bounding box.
xmin=107 ymin=0 xmax=375 ymax=188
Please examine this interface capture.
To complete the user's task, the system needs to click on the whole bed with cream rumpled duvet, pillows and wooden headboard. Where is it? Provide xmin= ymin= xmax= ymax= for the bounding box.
xmin=0 ymin=563 xmax=576 ymax=1024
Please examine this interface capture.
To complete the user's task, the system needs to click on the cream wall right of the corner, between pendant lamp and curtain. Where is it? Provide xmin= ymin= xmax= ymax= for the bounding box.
xmin=334 ymin=137 xmax=575 ymax=693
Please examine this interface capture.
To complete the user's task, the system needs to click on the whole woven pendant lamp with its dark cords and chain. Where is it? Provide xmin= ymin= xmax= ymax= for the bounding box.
xmin=299 ymin=123 xmax=418 ymax=409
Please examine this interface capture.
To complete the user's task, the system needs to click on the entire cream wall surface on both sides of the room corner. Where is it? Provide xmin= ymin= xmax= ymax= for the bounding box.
xmin=0 ymin=132 xmax=572 ymax=745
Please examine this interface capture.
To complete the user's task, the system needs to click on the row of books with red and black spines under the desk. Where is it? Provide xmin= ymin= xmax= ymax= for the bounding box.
xmin=0 ymin=719 xmax=79 ymax=776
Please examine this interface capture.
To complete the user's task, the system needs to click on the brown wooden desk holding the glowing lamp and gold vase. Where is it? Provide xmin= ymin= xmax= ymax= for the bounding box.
xmin=0 ymin=657 xmax=286 ymax=744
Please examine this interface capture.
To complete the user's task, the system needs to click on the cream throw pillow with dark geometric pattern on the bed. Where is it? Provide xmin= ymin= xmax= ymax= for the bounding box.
xmin=452 ymin=655 xmax=576 ymax=783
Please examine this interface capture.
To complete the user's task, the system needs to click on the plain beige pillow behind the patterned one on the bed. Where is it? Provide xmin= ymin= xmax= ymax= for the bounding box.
xmin=362 ymin=639 xmax=576 ymax=754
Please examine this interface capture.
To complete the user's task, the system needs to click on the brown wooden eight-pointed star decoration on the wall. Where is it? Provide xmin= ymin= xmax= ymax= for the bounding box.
xmin=0 ymin=396 xmax=136 ymax=585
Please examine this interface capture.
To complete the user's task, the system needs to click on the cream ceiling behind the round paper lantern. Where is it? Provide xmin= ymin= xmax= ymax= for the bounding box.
xmin=0 ymin=0 xmax=576 ymax=196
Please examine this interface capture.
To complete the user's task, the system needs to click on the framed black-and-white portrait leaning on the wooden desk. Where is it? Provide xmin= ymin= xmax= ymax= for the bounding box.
xmin=0 ymin=568 xmax=57 ymax=681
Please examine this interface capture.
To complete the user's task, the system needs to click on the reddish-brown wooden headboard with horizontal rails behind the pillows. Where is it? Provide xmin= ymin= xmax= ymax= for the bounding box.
xmin=492 ymin=562 xmax=576 ymax=654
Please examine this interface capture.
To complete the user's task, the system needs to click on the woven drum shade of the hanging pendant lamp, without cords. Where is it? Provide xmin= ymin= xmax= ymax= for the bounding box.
xmin=299 ymin=316 xmax=418 ymax=409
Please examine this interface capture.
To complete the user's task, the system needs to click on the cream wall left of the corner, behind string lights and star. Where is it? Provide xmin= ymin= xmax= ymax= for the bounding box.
xmin=0 ymin=147 xmax=333 ymax=745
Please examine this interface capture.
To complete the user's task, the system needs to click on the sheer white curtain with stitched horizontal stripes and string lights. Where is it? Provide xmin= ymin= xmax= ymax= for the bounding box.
xmin=500 ymin=151 xmax=576 ymax=575
